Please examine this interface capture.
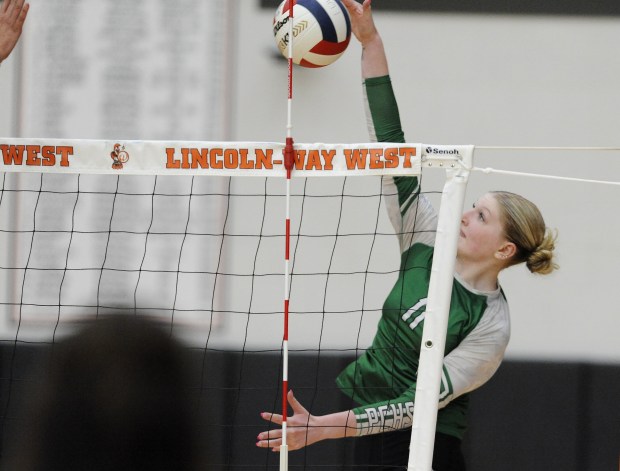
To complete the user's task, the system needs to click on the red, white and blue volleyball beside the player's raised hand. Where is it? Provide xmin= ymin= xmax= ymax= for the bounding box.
xmin=273 ymin=0 xmax=351 ymax=67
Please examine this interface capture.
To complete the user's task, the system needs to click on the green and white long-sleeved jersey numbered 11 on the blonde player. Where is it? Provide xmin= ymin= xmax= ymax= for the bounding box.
xmin=336 ymin=76 xmax=510 ymax=438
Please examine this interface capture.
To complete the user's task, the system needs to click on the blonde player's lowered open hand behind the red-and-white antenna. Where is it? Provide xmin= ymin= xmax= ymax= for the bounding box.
xmin=256 ymin=391 xmax=326 ymax=451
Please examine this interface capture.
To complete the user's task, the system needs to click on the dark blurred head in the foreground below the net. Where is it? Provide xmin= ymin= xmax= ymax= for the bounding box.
xmin=10 ymin=316 xmax=197 ymax=471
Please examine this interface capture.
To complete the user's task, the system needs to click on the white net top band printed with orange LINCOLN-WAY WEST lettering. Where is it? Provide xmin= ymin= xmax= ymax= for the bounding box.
xmin=0 ymin=138 xmax=422 ymax=177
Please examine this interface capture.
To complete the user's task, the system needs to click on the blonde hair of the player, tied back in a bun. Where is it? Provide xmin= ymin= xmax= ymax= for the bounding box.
xmin=491 ymin=191 xmax=558 ymax=275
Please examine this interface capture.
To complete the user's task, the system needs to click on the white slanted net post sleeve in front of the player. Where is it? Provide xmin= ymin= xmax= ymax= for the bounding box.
xmin=408 ymin=146 xmax=474 ymax=471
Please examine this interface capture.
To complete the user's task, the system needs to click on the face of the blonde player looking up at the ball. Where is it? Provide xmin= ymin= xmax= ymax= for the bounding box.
xmin=458 ymin=193 xmax=506 ymax=261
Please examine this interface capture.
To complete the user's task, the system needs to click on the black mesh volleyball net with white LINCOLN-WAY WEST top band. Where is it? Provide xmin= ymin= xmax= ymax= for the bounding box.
xmin=0 ymin=139 xmax=473 ymax=469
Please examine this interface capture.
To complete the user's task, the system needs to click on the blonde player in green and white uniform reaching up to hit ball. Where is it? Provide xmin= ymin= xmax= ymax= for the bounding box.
xmin=257 ymin=0 xmax=555 ymax=471
